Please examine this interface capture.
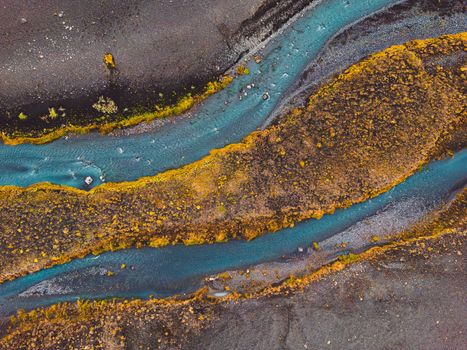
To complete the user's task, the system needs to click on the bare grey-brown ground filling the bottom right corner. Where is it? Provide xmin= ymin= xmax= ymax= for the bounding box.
xmin=185 ymin=231 xmax=467 ymax=350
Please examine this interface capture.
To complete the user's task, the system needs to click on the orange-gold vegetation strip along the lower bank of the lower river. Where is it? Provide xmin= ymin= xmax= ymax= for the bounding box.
xmin=0 ymin=189 xmax=467 ymax=349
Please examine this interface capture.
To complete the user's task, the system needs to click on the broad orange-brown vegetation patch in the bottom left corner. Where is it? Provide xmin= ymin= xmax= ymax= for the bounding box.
xmin=0 ymin=292 xmax=213 ymax=349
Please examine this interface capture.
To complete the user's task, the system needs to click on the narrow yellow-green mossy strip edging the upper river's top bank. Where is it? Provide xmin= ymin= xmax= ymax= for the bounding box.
xmin=0 ymin=75 xmax=234 ymax=146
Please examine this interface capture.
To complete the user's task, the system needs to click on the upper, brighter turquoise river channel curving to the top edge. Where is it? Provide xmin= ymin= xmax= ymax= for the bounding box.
xmin=0 ymin=0 xmax=400 ymax=187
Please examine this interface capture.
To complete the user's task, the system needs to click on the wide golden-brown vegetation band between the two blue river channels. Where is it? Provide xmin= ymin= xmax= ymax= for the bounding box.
xmin=0 ymin=33 xmax=467 ymax=281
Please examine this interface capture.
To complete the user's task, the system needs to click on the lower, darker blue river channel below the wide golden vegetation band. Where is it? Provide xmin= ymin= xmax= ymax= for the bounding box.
xmin=0 ymin=150 xmax=467 ymax=314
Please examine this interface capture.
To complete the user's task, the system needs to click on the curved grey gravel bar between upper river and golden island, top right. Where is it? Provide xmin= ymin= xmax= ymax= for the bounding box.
xmin=270 ymin=0 xmax=467 ymax=126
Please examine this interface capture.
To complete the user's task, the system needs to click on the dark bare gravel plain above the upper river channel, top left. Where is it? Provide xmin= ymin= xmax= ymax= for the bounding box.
xmin=0 ymin=0 xmax=312 ymax=131
